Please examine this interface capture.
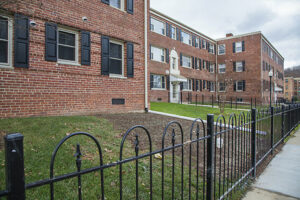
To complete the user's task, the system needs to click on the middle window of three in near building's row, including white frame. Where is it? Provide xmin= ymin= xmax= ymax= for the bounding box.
xmin=57 ymin=29 xmax=78 ymax=63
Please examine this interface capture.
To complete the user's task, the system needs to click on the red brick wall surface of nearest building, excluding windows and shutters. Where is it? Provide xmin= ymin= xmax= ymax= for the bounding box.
xmin=0 ymin=0 xmax=149 ymax=117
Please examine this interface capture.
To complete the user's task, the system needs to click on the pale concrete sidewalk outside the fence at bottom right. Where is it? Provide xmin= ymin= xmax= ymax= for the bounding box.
xmin=243 ymin=130 xmax=300 ymax=200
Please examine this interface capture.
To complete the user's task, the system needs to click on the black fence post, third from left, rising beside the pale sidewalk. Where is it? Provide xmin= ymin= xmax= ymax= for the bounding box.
xmin=251 ymin=108 xmax=256 ymax=178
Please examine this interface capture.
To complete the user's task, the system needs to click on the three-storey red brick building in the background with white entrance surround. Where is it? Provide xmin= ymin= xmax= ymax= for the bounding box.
xmin=148 ymin=9 xmax=284 ymax=104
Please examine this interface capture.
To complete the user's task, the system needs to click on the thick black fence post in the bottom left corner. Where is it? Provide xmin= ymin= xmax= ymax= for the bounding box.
xmin=4 ymin=133 xmax=25 ymax=200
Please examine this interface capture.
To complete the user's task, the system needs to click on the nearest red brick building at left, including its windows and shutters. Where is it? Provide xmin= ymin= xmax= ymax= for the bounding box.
xmin=0 ymin=0 xmax=149 ymax=117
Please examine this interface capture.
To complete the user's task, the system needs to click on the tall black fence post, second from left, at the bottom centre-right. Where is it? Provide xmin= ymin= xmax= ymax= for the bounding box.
xmin=206 ymin=114 xmax=215 ymax=200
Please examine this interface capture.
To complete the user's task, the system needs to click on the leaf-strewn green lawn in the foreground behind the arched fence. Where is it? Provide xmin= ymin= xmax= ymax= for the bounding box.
xmin=0 ymin=116 xmax=248 ymax=200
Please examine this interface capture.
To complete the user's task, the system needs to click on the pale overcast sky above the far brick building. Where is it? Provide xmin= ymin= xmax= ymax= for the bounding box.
xmin=150 ymin=0 xmax=300 ymax=68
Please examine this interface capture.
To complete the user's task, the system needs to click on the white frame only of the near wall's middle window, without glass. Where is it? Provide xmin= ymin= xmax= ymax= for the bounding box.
xmin=57 ymin=27 xmax=79 ymax=65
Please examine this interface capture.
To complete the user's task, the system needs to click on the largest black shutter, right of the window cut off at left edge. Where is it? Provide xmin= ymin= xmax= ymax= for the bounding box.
xmin=14 ymin=14 xmax=29 ymax=68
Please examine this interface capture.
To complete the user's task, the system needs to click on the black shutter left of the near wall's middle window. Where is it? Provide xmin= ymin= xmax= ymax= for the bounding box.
xmin=45 ymin=23 xmax=57 ymax=61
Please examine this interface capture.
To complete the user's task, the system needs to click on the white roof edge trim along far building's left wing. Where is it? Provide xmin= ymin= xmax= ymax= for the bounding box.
xmin=150 ymin=8 xmax=217 ymax=43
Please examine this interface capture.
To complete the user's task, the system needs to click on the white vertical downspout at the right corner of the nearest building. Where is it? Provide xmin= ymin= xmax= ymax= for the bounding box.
xmin=144 ymin=0 xmax=148 ymax=112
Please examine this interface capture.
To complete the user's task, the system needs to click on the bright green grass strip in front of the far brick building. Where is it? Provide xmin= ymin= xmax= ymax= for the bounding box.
xmin=151 ymin=102 xmax=246 ymax=121
